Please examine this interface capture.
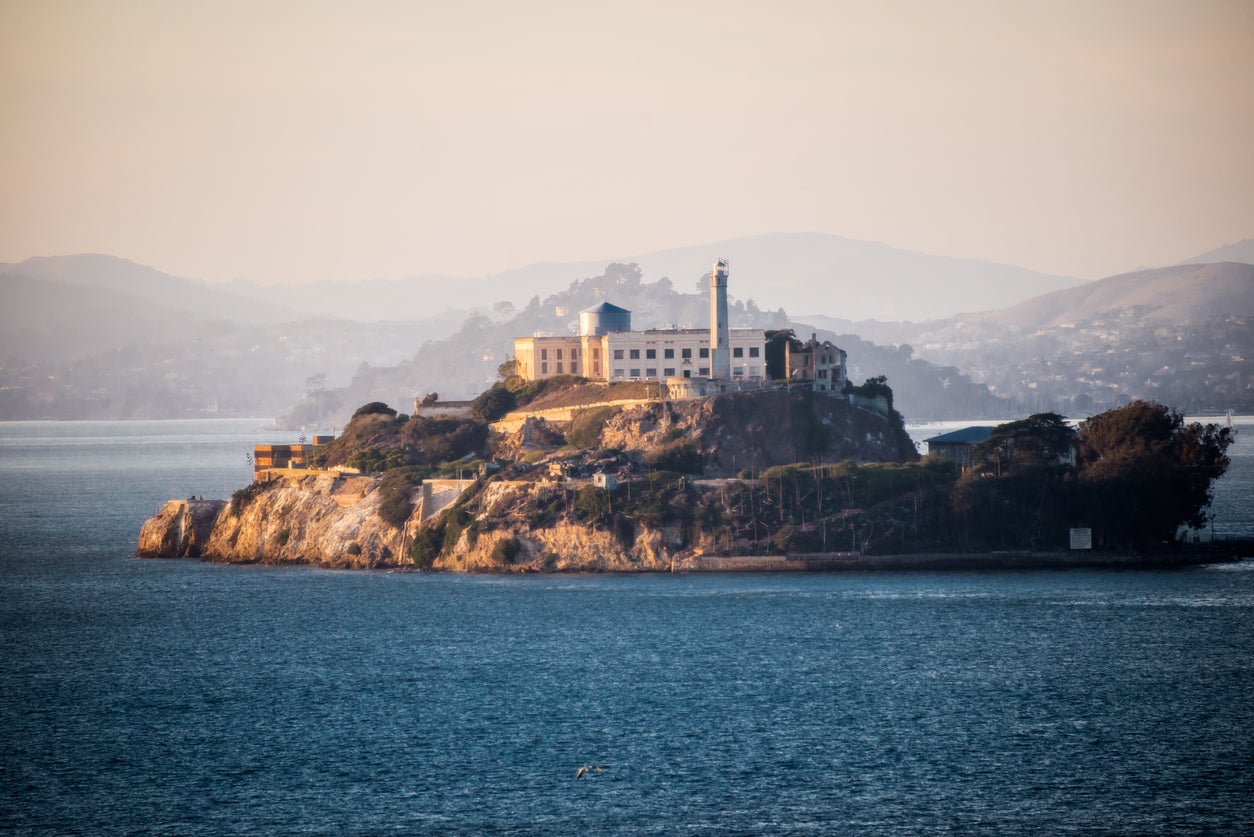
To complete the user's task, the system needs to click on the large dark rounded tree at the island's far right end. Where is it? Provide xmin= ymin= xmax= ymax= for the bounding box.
xmin=1077 ymin=402 xmax=1233 ymax=548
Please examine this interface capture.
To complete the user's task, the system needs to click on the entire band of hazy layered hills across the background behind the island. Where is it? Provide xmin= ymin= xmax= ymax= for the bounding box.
xmin=0 ymin=235 xmax=1254 ymax=418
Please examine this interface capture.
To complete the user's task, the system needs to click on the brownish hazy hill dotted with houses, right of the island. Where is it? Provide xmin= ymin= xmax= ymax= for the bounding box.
xmin=857 ymin=262 xmax=1254 ymax=417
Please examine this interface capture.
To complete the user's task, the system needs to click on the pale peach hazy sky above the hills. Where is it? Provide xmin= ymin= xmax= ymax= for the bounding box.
xmin=0 ymin=0 xmax=1254 ymax=282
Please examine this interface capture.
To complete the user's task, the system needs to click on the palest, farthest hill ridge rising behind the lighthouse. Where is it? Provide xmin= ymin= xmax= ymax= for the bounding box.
xmin=190 ymin=233 xmax=1082 ymax=320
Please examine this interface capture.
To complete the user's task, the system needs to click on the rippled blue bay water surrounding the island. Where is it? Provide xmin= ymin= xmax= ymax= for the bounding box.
xmin=0 ymin=422 xmax=1254 ymax=834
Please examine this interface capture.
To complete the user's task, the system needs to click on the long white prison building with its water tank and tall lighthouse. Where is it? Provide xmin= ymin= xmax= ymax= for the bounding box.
xmin=514 ymin=261 xmax=766 ymax=383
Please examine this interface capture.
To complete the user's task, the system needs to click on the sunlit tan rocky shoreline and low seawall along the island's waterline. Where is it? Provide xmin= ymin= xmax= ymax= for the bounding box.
xmin=135 ymin=491 xmax=1241 ymax=573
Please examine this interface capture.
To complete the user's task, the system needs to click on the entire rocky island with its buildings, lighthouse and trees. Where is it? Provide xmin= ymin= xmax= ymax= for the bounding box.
xmin=137 ymin=260 xmax=1246 ymax=572
